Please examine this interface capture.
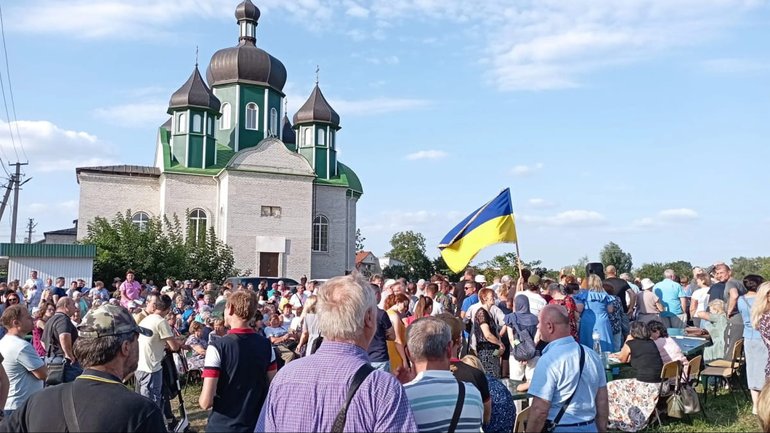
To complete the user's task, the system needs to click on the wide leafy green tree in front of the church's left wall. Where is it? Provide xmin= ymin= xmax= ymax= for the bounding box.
xmin=82 ymin=210 xmax=240 ymax=282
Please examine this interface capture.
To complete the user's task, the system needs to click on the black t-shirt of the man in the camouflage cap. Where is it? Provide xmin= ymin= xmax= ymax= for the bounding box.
xmin=0 ymin=369 xmax=166 ymax=432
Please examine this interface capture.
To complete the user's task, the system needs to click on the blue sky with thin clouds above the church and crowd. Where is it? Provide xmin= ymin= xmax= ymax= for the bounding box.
xmin=0 ymin=0 xmax=770 ymax=268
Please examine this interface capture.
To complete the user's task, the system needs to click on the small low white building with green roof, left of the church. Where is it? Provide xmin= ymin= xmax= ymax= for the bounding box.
xmin=0 ymin=244 xmax=96 ymax=287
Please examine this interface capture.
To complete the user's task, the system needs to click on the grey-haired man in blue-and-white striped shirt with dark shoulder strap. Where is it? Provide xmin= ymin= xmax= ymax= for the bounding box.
xmin=404 ymin=317 xmax=484 ymax=432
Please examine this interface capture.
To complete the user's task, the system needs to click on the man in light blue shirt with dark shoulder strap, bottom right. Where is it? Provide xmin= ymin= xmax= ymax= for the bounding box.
xmin=527 ymin=304 xmax=609 ymax=432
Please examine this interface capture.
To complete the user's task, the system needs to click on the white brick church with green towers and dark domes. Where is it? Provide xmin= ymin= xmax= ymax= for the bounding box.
xmin=76 ymin=0 xmax=363 ymax=280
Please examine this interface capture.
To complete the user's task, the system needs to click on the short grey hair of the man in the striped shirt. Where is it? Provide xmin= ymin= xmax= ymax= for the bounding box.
xmin=406 ymin=317 xmax=452 ymax=361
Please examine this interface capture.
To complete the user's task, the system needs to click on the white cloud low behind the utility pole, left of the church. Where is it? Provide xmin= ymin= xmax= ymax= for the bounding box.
xmin=0 ymin=120 xmax=117 ymax=172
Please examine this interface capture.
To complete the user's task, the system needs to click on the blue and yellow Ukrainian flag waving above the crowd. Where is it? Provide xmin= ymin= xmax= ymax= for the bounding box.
xmin=438 ymin=188 xmax=516 ymax=272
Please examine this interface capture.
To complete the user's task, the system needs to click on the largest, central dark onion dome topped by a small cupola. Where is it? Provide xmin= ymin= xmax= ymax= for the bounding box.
xmin=206 ymin=0 xmax=286 ymax=92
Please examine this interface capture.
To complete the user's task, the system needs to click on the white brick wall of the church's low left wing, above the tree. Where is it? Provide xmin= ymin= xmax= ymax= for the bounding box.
xmin=78 ymin=173 xmax=160 ymax=239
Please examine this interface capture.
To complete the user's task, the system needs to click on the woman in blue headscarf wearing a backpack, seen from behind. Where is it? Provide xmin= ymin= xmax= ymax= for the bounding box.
xmin=500 ymin=296 xmax=542 ymax=391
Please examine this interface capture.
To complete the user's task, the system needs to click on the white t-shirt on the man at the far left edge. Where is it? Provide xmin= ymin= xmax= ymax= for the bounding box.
xmin=0 ymin=335 xmax=45 ymax=410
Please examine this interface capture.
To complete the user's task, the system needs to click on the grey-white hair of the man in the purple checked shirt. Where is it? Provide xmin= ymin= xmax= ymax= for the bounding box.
xmin=316 ymin=275 xmax=377 ymax=341
